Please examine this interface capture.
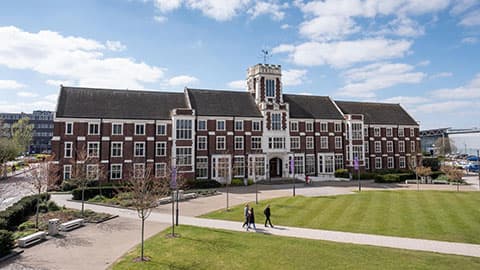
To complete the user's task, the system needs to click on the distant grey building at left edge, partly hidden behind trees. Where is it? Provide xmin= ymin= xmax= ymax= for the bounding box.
xmin=0 ymin=111 xmax=54 ymax=154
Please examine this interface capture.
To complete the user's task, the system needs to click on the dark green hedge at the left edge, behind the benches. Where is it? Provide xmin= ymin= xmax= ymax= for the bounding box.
xmin=0 ymin=193 xmax=50 ymax=231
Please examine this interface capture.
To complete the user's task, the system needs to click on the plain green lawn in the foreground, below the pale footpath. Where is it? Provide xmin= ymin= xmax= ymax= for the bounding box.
xmin=113 ymin=226 xmax=480 ymax=270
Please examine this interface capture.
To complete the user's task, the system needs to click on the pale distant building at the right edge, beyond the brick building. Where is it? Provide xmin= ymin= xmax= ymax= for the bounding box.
xmin=420 ymin=128 xmax=480 ymax=155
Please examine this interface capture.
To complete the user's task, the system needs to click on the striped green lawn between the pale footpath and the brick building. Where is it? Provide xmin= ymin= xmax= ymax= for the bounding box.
xmin=204 ymin=191 xmax=480 ymax=244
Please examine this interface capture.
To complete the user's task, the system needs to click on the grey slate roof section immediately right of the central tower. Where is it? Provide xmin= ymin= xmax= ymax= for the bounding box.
xmin=283 ymin=94 xmax=343 ymax=120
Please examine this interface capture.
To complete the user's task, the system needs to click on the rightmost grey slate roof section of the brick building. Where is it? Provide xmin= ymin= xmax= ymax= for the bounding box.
xmin=335 ymin=101 xmax=418 ymax=126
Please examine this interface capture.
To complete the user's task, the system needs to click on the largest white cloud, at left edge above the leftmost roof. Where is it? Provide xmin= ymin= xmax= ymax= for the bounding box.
xmin=0 ymin=26 xmax=163 ymax=88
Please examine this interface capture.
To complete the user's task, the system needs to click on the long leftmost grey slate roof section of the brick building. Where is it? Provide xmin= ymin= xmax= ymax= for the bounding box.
xmin=56 ymin=86 xmax=188 ymax=120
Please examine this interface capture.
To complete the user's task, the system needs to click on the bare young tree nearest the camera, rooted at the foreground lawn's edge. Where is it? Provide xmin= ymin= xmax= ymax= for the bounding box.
xmin=124 ymin=165 xmax=169 ymax=261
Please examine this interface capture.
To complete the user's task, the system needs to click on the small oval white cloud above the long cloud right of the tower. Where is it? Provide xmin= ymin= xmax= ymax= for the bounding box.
xmin=300 ymin=16 xmax=360 ymax=41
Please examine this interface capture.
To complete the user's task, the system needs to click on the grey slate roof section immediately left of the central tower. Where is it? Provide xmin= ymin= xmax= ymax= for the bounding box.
xmin=186 ymin=88 xmax=262 ymax=117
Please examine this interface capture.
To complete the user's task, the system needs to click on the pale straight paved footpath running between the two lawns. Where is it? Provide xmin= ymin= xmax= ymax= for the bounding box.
xmin=53 ymin=195 xmax=480 ymax=257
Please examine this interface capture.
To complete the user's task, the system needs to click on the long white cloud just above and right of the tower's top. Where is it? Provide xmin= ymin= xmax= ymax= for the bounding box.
xmin=272 ymin=38 xmax=412 ymax=68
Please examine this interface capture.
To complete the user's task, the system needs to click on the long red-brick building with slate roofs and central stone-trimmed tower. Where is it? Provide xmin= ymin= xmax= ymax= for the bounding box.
xmin=52 ymin=64 xmax=421 ymax=182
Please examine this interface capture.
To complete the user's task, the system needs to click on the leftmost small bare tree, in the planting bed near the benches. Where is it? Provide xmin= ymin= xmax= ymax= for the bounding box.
xmin=27 ymin=157 xmax=58 ymax=229
